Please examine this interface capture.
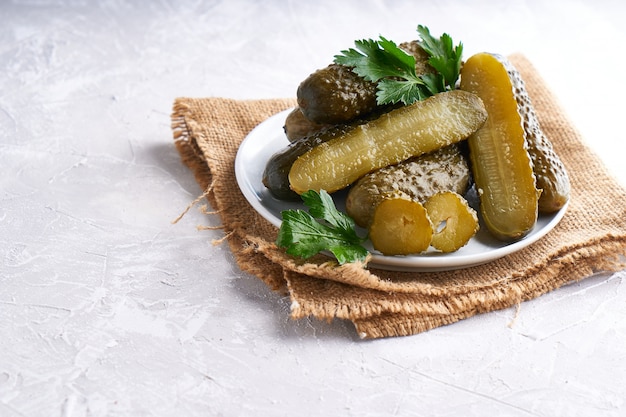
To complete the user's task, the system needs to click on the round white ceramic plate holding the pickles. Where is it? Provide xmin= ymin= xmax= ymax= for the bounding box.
xmin=235 ymin=110 xmax=567 ymax=272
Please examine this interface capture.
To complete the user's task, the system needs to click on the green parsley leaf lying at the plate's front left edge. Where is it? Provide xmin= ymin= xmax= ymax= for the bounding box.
xmin=276 ymin=190 xmax=368 ymax=264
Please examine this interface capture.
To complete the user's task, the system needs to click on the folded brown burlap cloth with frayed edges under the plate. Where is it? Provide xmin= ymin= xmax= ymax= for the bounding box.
xmin=172 ymin=54 xmax=626 ymax=338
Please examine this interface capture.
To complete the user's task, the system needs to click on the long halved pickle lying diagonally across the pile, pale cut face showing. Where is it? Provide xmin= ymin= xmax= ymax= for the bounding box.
xmin=289 ymin=90 xmax=487 ymax=194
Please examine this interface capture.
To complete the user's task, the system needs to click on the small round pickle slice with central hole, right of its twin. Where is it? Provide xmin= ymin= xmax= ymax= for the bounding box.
xmin=424 ymin=191 xmax=479 ymax=253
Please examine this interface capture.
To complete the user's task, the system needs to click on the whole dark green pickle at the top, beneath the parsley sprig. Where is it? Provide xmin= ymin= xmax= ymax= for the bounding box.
xmin=296 ymin=41 xmax=433 ymax=124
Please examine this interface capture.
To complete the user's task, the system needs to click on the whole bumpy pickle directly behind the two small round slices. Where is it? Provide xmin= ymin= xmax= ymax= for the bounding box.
xmin=346 ymin=144 xmax=470 ymax=227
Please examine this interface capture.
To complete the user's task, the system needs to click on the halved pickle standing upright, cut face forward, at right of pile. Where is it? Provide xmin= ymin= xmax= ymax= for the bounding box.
xmin=460 ymin=53 xmax=540 ymax=241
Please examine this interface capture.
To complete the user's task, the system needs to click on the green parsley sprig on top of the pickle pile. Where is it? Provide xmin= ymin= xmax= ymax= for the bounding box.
xmin=334 ymin=25 xmax=463 ymax=104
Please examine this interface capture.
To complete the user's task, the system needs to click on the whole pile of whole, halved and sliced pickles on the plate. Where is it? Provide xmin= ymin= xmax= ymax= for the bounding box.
xmin=263 ymin=30 xmax=570 ymax=255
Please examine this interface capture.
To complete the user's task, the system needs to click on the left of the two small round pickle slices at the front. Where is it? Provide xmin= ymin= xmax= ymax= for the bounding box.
xmin=369 ymin=198 xmax=433 ymax=256
